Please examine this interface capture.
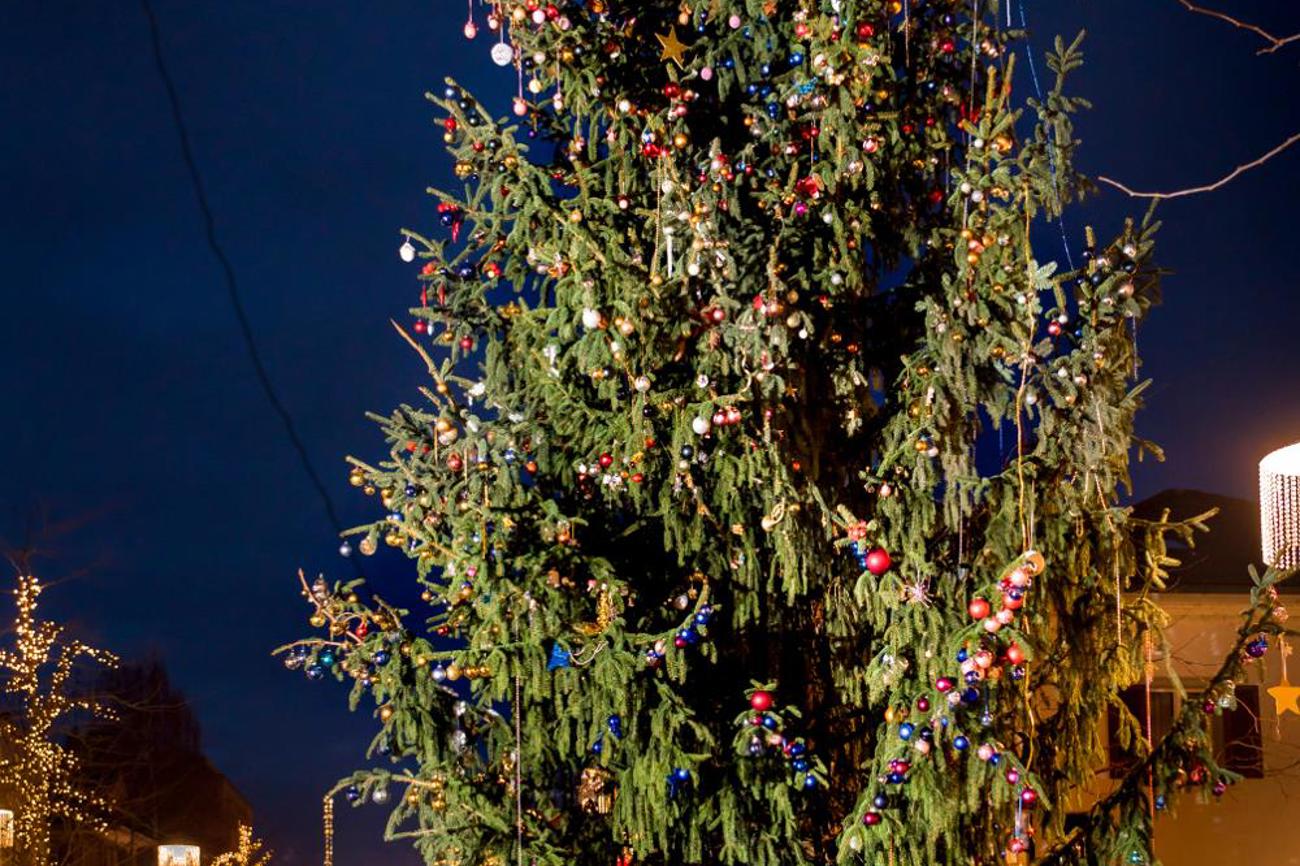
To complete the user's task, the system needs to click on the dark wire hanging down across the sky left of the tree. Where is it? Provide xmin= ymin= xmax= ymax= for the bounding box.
xmin=140 ymin=0 xmax=343 ymax=546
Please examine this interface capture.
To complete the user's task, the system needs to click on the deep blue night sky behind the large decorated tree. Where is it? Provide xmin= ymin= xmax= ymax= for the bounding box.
xmin=0 ymin=0 xmax=1300 ymax=866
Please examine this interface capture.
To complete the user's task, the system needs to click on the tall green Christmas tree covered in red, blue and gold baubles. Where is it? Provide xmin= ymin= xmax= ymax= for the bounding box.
xmin=286 ymin=0 xmax=1279 ymax=866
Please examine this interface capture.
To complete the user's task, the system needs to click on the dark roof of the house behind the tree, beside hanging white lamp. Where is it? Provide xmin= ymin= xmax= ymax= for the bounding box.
xmin=1134 ymin=490 xmax=1262 ymax=593
